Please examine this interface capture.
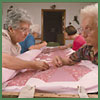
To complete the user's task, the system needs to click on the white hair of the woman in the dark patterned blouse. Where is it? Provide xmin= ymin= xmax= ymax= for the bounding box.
xmin=80 ymin=3 xmax=98 ymax=26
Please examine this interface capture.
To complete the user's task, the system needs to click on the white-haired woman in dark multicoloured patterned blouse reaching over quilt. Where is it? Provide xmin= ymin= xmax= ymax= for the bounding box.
xmin=53 ymin=4 xmax=98 ymax=67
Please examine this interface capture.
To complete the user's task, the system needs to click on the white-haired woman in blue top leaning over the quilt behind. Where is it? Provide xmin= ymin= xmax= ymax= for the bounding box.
xmin=19 ymin=25 xmax=47 ymax=53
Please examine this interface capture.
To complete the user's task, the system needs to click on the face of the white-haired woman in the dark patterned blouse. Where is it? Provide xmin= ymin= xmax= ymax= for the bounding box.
xmin=81 ymin=17 xmax=98 ymax=46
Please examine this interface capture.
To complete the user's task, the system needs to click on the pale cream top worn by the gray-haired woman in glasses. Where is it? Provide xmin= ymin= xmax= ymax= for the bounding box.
xmin=2 ymin=30 xmax=21 ymax=56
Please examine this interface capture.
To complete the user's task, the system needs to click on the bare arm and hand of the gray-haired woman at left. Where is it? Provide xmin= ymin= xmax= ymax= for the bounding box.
xmin=2 ymin=53 xmax=49 ymax=70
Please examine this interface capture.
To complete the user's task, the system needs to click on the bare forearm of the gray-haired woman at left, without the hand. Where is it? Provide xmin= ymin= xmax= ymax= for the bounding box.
xmin=2 ymin=54 xmax=33 ymax=70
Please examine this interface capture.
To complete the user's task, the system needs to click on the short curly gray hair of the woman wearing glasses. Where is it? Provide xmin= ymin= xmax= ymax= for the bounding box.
xmin=4 ymin=8 xmax=32 ymax=30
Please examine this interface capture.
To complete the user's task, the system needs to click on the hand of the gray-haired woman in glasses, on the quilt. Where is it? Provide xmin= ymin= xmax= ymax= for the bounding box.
xmin=34 ymin=61 xmax=49 ymax=70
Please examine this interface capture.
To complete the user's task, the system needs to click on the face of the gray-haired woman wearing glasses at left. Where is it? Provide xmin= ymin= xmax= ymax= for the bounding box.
xmin=11 ymin=22 xmax=30 ymax=43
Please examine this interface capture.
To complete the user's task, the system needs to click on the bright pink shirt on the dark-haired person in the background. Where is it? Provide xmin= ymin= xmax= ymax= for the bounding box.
xmin=72 ymin=35 xmax=86 ymax=51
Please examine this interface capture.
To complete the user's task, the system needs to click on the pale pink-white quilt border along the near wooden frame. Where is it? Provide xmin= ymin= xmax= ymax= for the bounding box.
xmin=2 ymin=68 xmax=98 ymax=94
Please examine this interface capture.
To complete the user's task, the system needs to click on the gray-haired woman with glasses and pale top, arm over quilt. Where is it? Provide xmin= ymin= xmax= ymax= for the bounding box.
xmin=2 ymin=8 xmax=48 ymax=70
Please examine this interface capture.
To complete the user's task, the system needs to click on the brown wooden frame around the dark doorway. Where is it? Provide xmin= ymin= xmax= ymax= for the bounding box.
xmin=41 ymin=9 xmax=66 ymax=44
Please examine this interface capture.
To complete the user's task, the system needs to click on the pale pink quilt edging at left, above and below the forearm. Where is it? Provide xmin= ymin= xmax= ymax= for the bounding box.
xmin=2 ymin=50 xmax=41 ymax=83
